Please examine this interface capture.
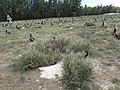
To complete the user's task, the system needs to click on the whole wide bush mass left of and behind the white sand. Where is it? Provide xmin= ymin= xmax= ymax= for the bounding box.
xmin=13 ymin=38 xmax=69 ymax=70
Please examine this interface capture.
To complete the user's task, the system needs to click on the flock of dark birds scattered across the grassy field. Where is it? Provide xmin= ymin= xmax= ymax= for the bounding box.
xmin=0 ymin=14 xmax=120 ymax=58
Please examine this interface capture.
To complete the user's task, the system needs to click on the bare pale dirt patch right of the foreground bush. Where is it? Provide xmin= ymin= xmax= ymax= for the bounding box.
xmin=93 ymin=58 xmax=116 ymax=90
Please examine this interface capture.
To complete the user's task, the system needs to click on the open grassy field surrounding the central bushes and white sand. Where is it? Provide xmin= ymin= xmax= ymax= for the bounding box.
xmin=0 ymin=15 xmax=120 ymax=90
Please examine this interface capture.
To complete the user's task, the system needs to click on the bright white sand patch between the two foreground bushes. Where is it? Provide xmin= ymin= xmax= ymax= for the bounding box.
xmin=39 ymin=62 xmax=63 ymax=79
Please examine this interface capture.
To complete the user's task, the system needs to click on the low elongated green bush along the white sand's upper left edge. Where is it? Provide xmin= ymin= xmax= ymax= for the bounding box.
xmin=13 ymin=51 xmax=61 ymax=70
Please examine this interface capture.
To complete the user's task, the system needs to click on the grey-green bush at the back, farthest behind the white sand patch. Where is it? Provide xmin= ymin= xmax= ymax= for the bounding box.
xmin=36 ymin=36 xmax=70 ymax=53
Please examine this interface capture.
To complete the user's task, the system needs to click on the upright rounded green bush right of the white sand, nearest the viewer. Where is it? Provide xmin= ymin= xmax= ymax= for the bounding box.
xmin=62 ymin=53 xmax=93 ymax=90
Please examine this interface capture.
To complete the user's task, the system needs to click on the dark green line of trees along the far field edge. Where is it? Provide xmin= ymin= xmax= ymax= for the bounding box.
xmin=0 ymin=0 xmax=119 ymax=21
